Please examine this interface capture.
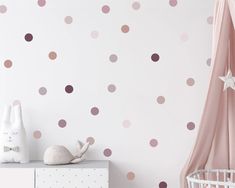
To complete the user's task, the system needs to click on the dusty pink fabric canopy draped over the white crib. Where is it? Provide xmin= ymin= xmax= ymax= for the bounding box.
xmin=181 ymin=0 xmax=235 ymax=188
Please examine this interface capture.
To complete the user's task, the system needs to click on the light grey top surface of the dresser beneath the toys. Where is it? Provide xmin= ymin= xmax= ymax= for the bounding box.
xmin=0 ymin=160 xmax=109 ymax=168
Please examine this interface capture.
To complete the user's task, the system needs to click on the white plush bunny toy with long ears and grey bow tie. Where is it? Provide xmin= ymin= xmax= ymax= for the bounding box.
xmin=0 ymin=105 xmax=29 ymax=163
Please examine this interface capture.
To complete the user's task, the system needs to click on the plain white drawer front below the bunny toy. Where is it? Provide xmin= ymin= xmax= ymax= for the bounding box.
xmin=0 ymin=168 xmax=34 ymax=188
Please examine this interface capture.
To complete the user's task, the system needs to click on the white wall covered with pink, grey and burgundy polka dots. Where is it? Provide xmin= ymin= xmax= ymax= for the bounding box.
xmin=0 ymin=0 xmax=213 ymax=188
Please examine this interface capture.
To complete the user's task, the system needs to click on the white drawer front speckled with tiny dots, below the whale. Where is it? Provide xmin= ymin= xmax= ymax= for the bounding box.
xmin=36 ymin=168 xmax=109 ymax=188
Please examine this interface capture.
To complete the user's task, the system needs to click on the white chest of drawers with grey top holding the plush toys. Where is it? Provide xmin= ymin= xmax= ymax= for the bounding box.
xmin=0 ymin=161 xmax=109 ymax=188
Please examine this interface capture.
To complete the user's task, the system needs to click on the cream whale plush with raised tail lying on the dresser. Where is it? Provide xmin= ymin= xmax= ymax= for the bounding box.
xmin=44 ymin=141 xmax=89 ymax=165
